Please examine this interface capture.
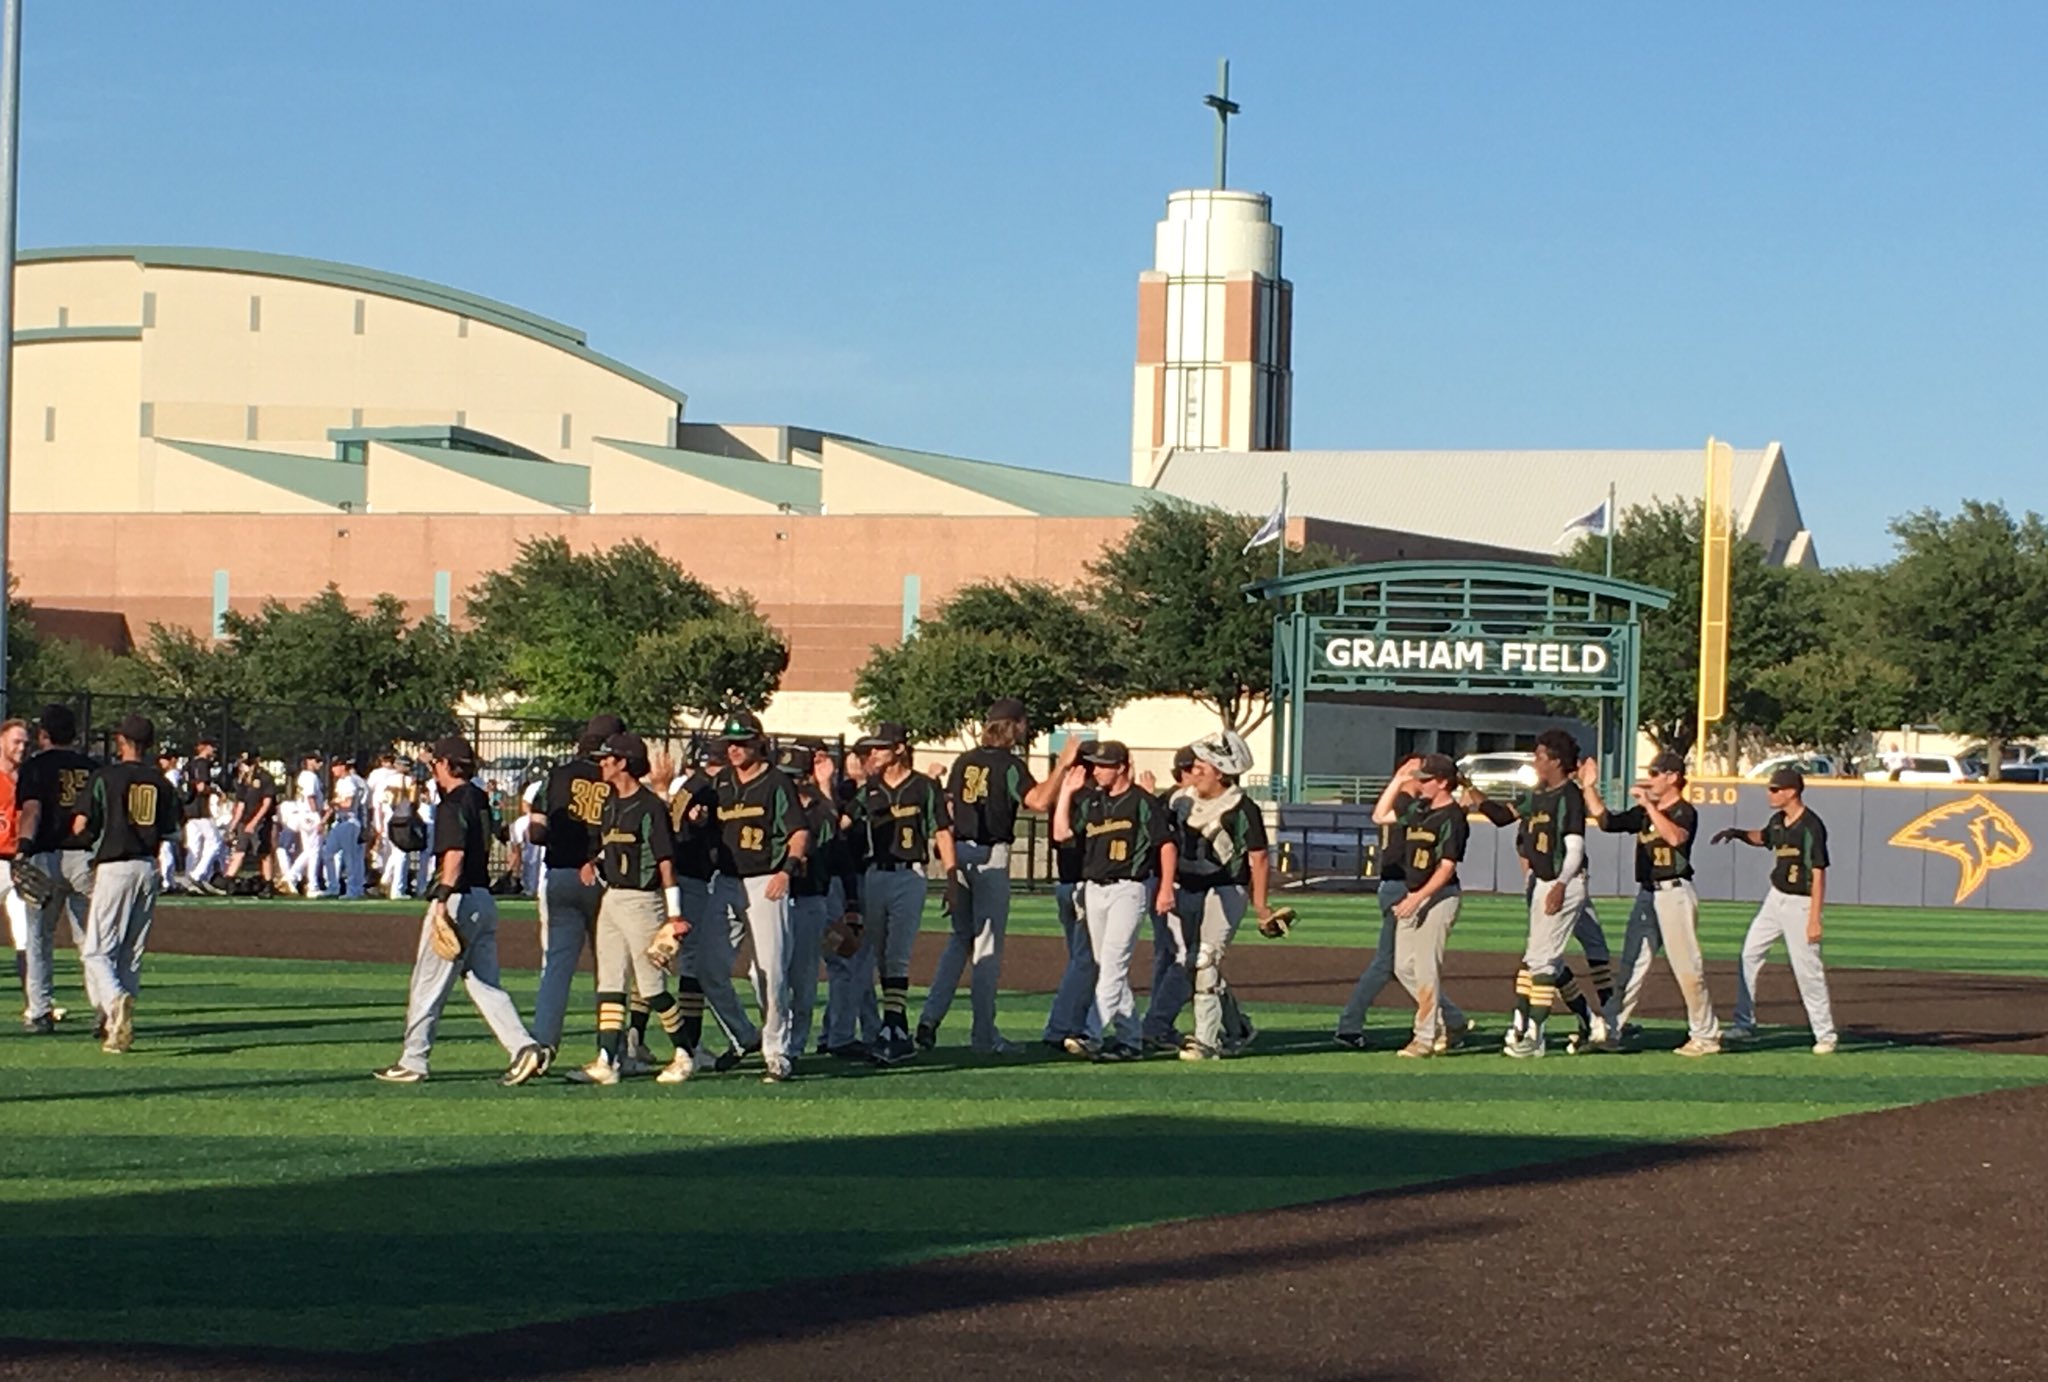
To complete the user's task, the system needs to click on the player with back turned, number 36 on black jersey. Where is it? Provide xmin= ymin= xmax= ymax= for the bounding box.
xmin=526 ymin=715 xmax=625 ymax=1063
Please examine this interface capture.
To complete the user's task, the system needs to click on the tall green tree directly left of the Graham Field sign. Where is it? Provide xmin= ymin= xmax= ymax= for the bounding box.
xmin=1087 ymin=500 xmax=1341 ymax=733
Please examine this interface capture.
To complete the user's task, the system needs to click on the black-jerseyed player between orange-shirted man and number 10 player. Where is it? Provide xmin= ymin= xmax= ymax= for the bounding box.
xmin=14 ymin=704 xmax=106 ymax=1036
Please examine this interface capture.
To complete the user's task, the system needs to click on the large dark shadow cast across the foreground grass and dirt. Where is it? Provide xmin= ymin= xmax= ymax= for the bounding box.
xmin=0 ymin=1108 xmax=1729 ymax=1378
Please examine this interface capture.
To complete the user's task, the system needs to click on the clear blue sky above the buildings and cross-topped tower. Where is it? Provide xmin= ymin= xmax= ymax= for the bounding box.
xmin=20 ymin=0 xmax=2048 ymax=563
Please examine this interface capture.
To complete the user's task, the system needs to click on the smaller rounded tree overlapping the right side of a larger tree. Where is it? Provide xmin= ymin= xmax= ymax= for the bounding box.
xmin=616 ymin=600 xmax=788 ymax=725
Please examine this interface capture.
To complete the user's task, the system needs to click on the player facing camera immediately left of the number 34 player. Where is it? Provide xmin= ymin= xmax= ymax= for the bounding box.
xmin=854 ymin=723 xmax=958 ymax=1065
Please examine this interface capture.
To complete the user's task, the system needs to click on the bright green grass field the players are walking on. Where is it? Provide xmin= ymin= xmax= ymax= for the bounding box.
xmin=12 ymin=899 xmax=2048 ymax=1349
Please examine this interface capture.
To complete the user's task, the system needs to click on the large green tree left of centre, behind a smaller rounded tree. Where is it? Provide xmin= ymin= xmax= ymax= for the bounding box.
xmin=465 ymin=536 xmax=727 ymax=721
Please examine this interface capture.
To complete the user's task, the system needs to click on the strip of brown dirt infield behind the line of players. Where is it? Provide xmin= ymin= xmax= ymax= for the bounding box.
xmin=150 ymin=903 xmax=2048 ymax=1054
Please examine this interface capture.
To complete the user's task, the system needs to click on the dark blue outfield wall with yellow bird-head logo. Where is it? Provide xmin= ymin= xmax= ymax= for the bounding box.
xmin=1278 ymin=780 xmax=2048 ymax=911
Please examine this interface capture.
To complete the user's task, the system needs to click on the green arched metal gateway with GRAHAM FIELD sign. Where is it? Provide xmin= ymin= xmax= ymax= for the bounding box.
xmin=1245 ymin=561 xmax=1671 ymax=801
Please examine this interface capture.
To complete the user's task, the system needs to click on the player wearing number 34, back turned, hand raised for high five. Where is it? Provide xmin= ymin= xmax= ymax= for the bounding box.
xmin=918 ymin=696 xmax=1079 ymax=1054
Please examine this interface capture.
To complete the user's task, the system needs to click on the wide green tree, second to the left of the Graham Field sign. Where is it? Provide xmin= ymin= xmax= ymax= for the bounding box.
xmin=854 ymin=579 xmax=1126 ymax=739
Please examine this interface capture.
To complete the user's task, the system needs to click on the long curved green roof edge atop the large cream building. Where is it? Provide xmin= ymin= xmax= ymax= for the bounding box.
xmin=18 ymin=246 xmax=688 ymax=405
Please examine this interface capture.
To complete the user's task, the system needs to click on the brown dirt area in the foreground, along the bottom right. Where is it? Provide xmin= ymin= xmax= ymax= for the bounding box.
xmin=16 ymin=1089 xmax=2048 ymax=1382
